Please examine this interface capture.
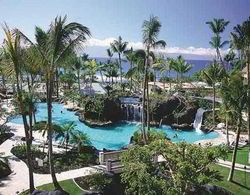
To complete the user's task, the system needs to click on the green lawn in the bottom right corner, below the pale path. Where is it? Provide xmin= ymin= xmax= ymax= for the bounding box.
xmin=213 ymin=165 xmax=250 ymax=195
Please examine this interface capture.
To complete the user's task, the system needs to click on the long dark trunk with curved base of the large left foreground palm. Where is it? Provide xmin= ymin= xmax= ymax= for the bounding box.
xmin=47 ymin=75 xmax=62 ymax=190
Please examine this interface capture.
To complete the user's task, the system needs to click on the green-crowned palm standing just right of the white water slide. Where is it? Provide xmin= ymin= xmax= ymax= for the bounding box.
xmin=201 ymin=61 xmax=224 ymax=126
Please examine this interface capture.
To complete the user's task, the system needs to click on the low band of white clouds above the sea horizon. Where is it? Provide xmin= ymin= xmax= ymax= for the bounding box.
xmin=87 ymin=37 xmax=227 ymax=57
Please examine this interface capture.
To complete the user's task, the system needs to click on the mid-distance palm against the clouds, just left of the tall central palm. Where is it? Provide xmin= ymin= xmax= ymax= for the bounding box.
xmin=111 ymin=36 xmax=128 ymax=83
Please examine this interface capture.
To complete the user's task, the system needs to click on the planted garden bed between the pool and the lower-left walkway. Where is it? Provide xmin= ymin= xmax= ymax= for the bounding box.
xmin=11 ymin=145 xmax=97 ymax=174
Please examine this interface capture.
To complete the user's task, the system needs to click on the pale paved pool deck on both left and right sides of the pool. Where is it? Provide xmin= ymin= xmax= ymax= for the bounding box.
xmin=0 ymin=99 xmax=249 ymax=195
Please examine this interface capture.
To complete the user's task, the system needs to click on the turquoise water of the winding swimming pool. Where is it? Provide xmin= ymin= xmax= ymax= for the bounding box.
xmin=11 ymin=103 xmax=218 ymax=150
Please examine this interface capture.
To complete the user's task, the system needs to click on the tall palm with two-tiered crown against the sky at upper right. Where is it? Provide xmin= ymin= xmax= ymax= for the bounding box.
xmin=206 ymin=18 xmax=229 ymax=64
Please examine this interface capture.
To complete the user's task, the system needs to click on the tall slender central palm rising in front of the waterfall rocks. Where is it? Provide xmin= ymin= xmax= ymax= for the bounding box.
xmin=142 ymin=16 xmax=166 ymax=143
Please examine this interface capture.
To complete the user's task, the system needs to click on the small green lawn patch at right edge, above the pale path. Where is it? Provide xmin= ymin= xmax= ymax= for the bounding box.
xmin=226 ymin=146 xmax=250 ymax=165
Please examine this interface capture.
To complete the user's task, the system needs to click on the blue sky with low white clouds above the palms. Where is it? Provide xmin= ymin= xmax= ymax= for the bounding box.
xmin=0 ymin=0 xmax=250 ymax=59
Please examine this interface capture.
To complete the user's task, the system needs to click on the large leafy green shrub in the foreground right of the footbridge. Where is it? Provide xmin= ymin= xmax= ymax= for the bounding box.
xmin=121 ymin=140 xmax=229 ymax=195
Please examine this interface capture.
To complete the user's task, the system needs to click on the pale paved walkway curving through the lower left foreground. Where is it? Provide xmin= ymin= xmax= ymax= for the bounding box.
xmin=0 ymin=125 xmax=103 ymax=195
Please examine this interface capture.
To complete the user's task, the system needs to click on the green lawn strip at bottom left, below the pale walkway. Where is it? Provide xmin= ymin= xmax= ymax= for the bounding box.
xmin=20 ymin=179 xmax=84 ymax=195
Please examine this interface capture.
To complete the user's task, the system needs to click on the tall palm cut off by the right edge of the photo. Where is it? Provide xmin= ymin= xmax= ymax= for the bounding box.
xmin=231 ymin=17 xmax=250 ymax=143
